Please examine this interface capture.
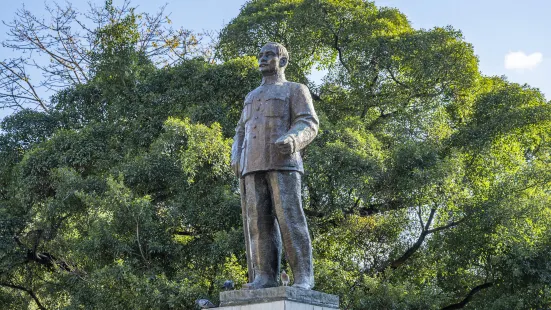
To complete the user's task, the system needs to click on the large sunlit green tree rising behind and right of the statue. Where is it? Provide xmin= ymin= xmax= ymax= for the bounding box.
xmin=219 ymin=0 xmax=549 ymax=309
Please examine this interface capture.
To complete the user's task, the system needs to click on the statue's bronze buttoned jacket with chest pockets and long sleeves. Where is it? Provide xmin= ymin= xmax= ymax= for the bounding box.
xmin=232 ymin=81 xmax=319 ymax=177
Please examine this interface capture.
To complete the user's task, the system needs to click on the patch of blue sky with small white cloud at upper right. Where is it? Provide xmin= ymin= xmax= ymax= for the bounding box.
xmin=375 ymin=0 xmax=551 ymax=100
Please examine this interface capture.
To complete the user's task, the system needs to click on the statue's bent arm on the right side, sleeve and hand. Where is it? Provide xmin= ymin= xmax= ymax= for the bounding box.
xmin=279 ymin=84 xmax=319 ymax=153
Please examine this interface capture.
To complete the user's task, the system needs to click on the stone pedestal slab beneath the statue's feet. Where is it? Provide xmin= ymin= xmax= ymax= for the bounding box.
xmin=218 ymin=286 xmax=339 ymax=310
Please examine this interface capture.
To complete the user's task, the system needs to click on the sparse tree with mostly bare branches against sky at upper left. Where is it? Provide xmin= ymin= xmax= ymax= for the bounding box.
xmin=0 ymin=0 xmax=212 ymax=112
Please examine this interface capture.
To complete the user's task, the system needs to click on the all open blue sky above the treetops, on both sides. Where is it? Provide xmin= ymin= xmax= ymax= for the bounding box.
xmin=0 ymin=0 xmax=551 ymax=118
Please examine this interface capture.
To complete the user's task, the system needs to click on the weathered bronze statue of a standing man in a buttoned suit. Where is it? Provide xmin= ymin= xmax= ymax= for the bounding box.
xmin=232 ymin=43 xmax=319 ymax=289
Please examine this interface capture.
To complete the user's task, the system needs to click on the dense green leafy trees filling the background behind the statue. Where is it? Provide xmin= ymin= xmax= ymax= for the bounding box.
xmin=0 ymin=0 xmax=551 ymax=309
